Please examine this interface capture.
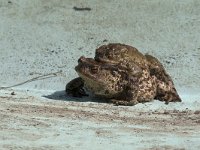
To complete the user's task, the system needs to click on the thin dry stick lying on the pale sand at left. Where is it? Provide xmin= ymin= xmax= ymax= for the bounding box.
xmin=0 ymin=71 xmax=62 ymax=90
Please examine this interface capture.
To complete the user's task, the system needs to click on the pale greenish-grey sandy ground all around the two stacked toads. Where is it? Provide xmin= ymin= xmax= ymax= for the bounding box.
xmin=0 ymin=0 xmax=200 ymax=150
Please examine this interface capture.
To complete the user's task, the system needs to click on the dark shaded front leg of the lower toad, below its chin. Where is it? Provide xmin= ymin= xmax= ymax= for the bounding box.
xmin=65 ymin=77 xmax=88 ymax=97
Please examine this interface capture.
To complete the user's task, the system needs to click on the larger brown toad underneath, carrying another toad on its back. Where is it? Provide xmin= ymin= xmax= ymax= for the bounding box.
xmin=66 ymin=56 xmax=156 ymax=105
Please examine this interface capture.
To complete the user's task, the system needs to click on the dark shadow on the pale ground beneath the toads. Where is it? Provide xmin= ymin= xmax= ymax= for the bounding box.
xmin=43 ymin=91 xmax=108 ymax=103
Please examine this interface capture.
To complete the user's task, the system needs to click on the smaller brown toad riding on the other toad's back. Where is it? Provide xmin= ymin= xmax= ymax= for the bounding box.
xmin=95 ymin=43 xmax=181 ymax=103
